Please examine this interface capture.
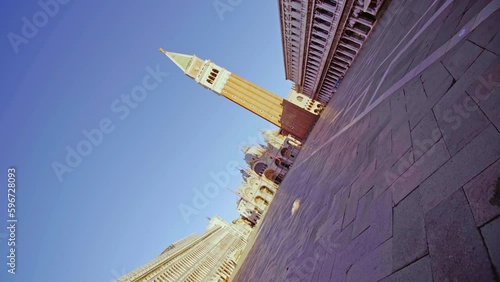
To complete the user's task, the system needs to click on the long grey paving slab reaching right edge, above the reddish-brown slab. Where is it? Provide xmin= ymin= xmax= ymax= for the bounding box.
xmin=420 ymin=125 xmax=500 ymax=212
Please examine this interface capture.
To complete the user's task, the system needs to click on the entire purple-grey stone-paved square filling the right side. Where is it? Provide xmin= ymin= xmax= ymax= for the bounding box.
xmin=234 ymin=0 xmax=500 ymax=282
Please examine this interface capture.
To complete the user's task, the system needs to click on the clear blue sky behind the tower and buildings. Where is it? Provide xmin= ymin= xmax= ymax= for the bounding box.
xmin=0 ymin=0 xmax=291 ymax=282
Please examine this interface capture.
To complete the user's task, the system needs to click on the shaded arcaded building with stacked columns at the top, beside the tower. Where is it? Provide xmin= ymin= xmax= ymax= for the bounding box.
xmin=279 ymin=0 xmax=384 ymax=105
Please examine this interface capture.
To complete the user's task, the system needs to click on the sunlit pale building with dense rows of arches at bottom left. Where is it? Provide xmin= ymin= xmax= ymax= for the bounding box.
xmin=116 ymin=216 xmax=251 ymax=282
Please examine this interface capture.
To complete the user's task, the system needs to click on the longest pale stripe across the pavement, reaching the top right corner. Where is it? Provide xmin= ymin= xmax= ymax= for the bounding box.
xmin=293 ymin=0 xmax=500 ymax=169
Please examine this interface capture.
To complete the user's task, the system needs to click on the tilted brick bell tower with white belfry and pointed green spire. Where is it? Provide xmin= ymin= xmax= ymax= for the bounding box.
xmin=160 ymin=48 xmax=318 ymax=140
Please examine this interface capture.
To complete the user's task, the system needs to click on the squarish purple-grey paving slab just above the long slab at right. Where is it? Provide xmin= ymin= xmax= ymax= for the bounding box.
xmin=435 ymin=92 xmax=490 ymax=156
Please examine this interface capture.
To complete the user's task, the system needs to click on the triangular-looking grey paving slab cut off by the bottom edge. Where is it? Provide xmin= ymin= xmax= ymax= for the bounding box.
xmin=380 ymin=256 xmax=433 ymax=282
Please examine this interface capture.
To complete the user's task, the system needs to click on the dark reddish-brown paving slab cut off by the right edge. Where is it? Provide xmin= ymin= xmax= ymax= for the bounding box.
xmin=464 ymin=160 xmax=500 ymax=226
